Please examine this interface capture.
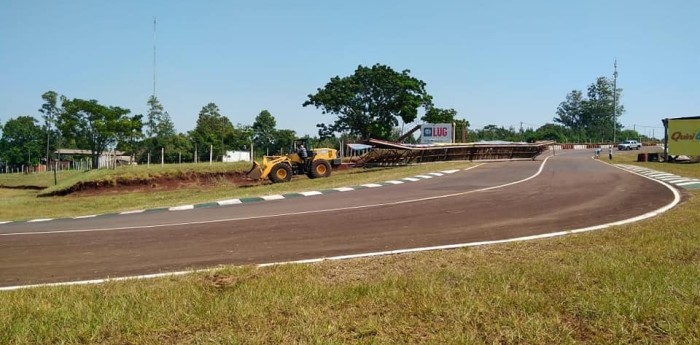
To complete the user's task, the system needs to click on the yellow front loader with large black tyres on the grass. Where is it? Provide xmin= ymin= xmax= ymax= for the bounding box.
xmin=247 ymin=148 xmax=341 ymax=183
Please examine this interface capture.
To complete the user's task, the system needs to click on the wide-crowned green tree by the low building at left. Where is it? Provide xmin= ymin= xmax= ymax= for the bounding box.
xmin=57 ymin=98 xmax=133 ymax=168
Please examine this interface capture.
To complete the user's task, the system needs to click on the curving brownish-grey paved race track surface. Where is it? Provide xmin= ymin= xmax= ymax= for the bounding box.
xmin=0 ymin=151 xmax=673 ymax=287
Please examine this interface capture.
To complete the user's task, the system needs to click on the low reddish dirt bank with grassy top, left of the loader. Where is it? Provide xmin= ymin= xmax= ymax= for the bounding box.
xmin=36 ymin=171 xmax=262 ymax=197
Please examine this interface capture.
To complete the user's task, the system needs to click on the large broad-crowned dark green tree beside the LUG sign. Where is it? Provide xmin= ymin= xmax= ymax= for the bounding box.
xmin=303 ymin=64 xmax=432 ymax=139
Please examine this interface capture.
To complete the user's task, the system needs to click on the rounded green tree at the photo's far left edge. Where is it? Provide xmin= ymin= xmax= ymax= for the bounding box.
xmin=0 ymin=116 xmax=45 ymax=167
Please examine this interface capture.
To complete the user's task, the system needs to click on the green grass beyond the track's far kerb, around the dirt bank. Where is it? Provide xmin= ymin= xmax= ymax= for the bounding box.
xmin=0 ymin=162 xmax=474 ymax=221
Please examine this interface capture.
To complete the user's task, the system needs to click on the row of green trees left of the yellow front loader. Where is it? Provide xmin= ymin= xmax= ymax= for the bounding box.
xmin=0 ymin=91 xmax=296 ymax=168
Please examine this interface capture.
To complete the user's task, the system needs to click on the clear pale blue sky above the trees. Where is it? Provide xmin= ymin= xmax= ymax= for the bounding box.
xmin=0 ymin=0 xmax=700 ymax=137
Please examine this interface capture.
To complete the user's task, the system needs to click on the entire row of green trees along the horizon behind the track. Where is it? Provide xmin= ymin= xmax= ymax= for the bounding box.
xmin=0 ymin=64 xmax=639 ymax=167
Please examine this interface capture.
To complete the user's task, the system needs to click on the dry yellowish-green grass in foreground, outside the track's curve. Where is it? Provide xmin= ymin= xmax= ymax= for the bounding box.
xmin=0 ymin=154 xmax=700 ymax=344
